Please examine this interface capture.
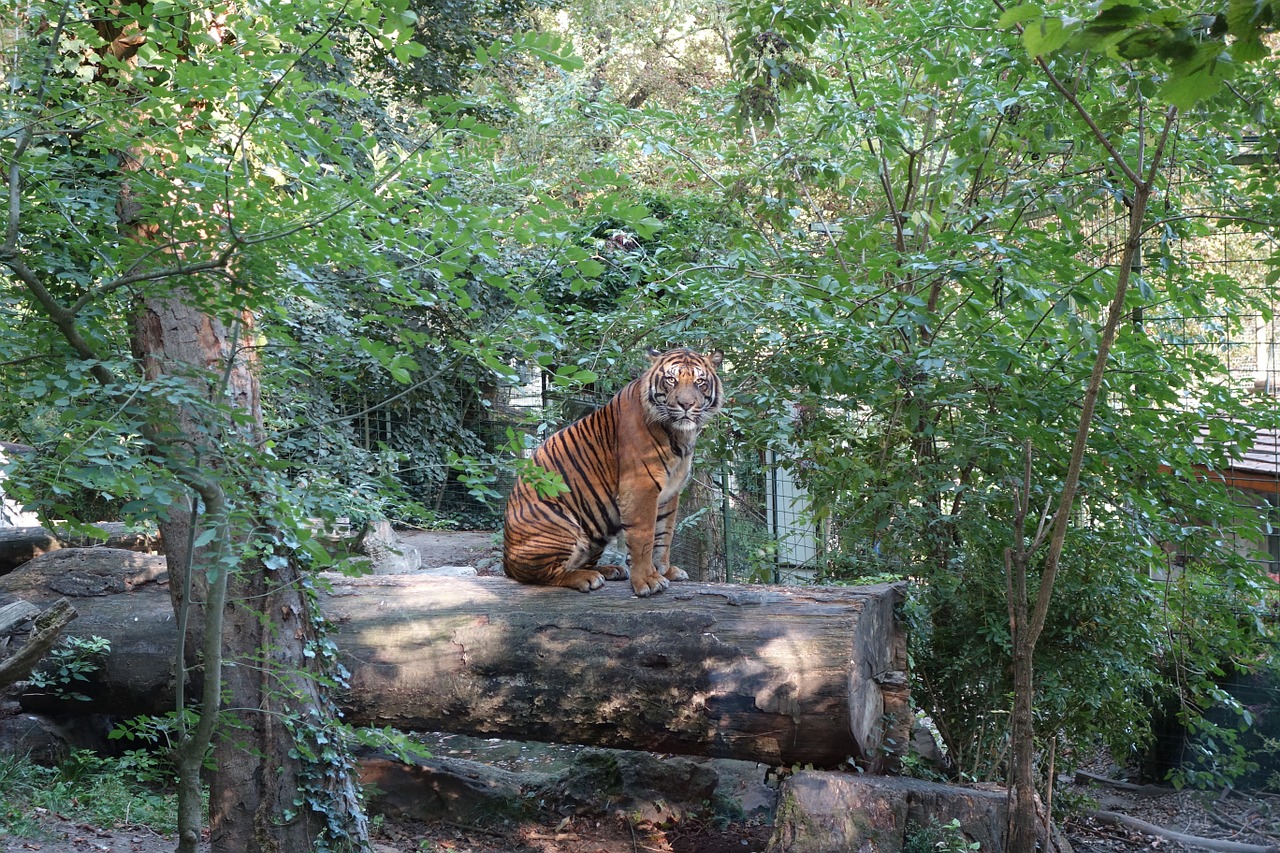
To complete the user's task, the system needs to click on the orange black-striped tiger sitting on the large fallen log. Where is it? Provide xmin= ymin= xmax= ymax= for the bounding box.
xmin=502 ymin=350 xmax=723 ymax=598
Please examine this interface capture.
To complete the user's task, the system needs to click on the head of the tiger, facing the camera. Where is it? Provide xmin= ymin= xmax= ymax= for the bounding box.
xmin=641 ymin=350 xmax=724 ymax=438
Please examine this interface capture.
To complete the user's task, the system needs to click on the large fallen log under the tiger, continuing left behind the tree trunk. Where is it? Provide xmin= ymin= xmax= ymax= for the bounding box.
xmin=0 ymin=548 xmax=910 ymax=771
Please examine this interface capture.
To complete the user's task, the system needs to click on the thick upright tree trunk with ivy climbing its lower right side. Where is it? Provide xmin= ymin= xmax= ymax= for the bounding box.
xmin=133 ymin=295 xmax=367 ymax=853
